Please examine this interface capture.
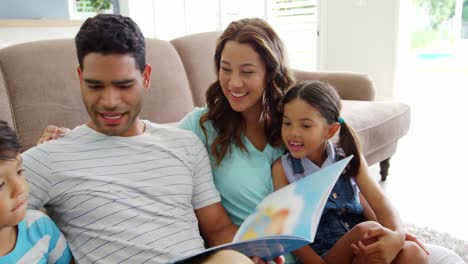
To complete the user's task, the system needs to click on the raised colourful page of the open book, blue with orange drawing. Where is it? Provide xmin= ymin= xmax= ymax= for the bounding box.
xmin=233 ymin=156 xmax=352 ymax=242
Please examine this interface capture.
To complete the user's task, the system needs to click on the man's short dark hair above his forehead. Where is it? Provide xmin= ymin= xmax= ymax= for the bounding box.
xmin=75 ymin=14 xmax=146 ymax=72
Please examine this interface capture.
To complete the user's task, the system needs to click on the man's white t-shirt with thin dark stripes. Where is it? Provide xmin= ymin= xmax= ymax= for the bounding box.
xmin=22 ymin=121 xmax=220 ymax=263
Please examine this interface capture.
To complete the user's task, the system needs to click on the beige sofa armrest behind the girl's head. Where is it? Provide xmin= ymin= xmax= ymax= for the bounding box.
xmin=293 ymin=70 xmax=375 ymax=101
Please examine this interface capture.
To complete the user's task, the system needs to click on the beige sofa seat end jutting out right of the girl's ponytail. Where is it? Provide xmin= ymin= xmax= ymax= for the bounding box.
xmin=342 ymin=100 xmax=411 ymax=165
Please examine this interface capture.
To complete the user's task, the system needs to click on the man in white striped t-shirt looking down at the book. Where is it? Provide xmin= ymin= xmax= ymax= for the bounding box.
xmin=22 ymin=15 xmax=276 ymax=263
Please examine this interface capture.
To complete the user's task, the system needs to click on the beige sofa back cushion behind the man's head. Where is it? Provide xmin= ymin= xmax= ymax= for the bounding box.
xmin=0 ymin=39 xmax=193 ymax=150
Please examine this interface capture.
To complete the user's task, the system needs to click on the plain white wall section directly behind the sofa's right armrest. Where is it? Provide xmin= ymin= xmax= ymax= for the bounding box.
xmin=318 ymin=0 xmax=400 ymax=97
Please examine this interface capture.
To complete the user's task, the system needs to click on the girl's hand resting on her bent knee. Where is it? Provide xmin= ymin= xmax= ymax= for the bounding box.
xmin=351 ymin=227 xmax=405 ymax=263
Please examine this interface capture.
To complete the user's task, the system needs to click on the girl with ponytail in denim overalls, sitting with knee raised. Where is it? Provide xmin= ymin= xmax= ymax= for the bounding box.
xmin=272 ymin=81 xmax=427 ymax=263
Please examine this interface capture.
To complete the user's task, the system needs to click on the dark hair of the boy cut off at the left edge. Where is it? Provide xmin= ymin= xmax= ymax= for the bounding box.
xmin=0 ymin=120 xmax=21 ymax=160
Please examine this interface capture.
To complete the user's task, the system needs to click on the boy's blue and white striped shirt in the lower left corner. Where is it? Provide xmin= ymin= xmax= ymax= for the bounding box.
xmin=0 ymin=210 xmax=71 ymax=264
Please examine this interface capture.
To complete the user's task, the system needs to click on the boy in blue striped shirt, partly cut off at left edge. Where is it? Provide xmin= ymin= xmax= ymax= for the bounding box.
xmin=0 ymin=121 xmax=72 ymax=264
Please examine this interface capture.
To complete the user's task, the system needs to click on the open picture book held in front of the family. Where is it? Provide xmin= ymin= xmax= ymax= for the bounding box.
xmin=170 ymin=156 xmax=352 ymax=264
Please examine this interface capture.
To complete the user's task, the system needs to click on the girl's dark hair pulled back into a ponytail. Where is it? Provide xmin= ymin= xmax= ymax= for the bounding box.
xmin=281 ymin=81 xmax=361 ymax=177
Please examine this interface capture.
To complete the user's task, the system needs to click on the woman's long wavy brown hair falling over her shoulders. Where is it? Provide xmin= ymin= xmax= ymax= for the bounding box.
xmin=200 ymin=18 xmax=293 ymax=165
